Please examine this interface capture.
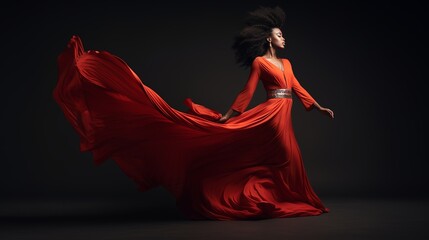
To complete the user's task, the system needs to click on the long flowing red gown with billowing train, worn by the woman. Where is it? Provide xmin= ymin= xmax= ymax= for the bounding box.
xmin=53 ymin=36 xmax=329 ymax=220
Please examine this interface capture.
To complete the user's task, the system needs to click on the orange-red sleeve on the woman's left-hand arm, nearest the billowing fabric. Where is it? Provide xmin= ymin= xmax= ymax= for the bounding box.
xmin=231 ymin=59 xmax=261 ymax=113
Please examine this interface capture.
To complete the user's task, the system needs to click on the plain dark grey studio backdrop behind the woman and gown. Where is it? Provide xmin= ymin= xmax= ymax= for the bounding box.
xmin=0 ymin=1 xmax=428 ymax=204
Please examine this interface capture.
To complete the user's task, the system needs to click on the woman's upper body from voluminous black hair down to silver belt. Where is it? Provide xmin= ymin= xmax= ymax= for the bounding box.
xmin=219 ymin=7 xmax=334 ymax=122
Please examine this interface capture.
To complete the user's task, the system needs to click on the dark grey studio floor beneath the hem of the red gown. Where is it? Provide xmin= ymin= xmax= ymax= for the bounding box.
xmin=0 ymin=198 xmax=429 ymax=240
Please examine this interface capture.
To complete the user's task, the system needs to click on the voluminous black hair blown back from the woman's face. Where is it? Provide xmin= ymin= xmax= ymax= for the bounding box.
xmin=232 ymin=6 xmax=286 ymax=67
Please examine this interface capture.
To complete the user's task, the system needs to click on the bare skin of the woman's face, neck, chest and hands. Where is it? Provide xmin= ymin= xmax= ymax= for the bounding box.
xmin=218 ymin=28 xmax=334 ymax=123
